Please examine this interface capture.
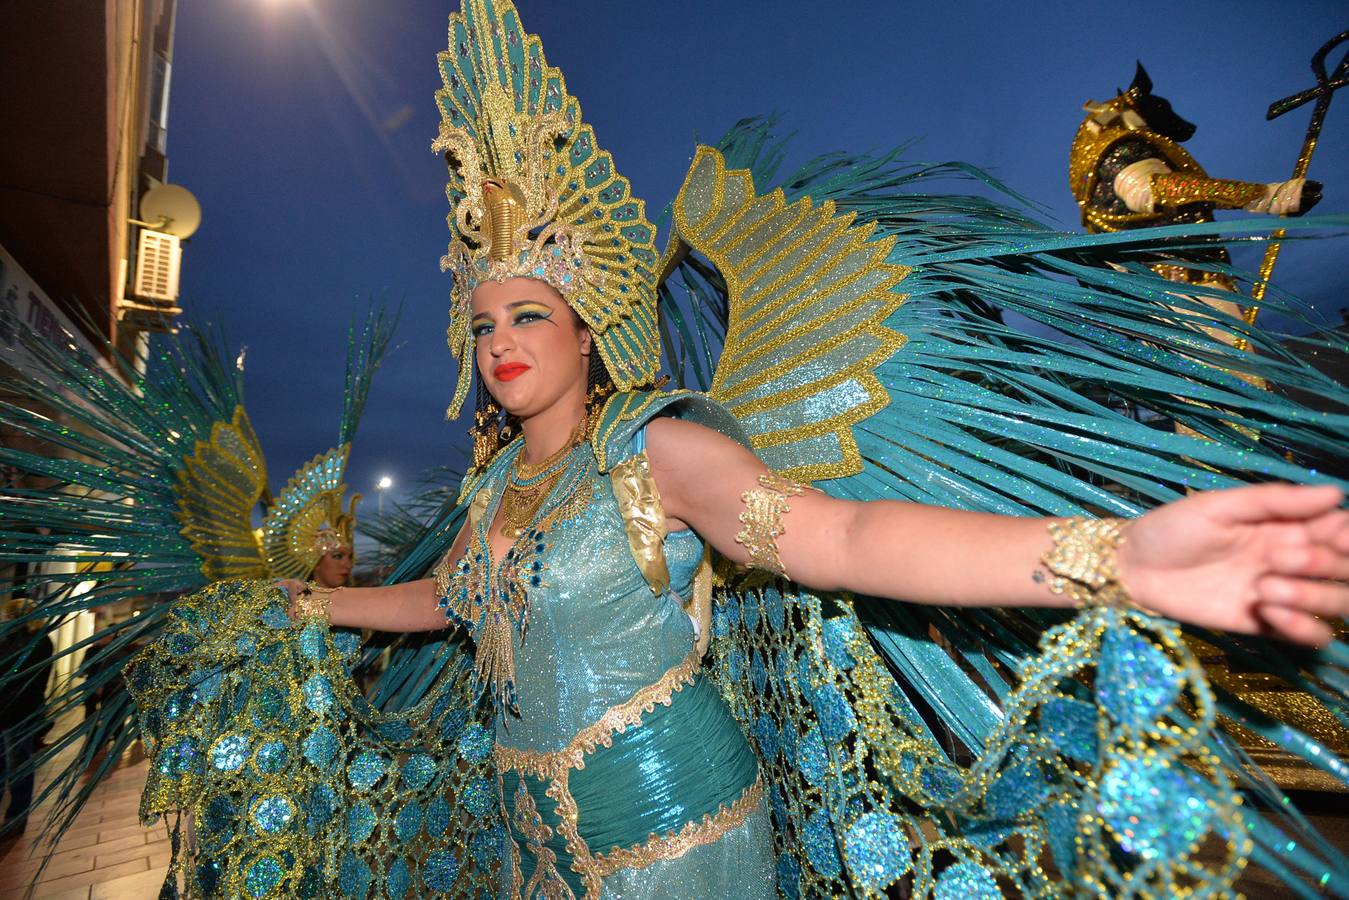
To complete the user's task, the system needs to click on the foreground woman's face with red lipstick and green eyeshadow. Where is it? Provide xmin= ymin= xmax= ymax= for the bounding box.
xmin=471 ymin=278 xmax=591 ymax=418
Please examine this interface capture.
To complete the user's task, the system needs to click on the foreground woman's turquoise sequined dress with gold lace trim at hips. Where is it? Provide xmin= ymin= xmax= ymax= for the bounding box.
xmin=441 ymin=418 xmax=776 ymax=899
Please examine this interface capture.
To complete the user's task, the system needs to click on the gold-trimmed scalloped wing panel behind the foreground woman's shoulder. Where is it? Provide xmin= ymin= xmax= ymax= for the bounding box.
xmin=672 ymin=147 xmax=909 ymax=480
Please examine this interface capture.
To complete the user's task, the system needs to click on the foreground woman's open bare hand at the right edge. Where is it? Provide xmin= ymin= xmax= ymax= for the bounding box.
xmin=1118 ymin=484 xmax=1349 ymax=646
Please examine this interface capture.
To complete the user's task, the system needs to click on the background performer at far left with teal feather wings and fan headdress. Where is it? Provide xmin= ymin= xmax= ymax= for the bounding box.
xmin=0 ymin=310 xmax=393 ymax=858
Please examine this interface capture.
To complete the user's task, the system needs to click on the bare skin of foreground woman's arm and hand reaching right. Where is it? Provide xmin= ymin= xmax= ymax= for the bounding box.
xmin=648 ymin=418 xmax=1349 ymax=644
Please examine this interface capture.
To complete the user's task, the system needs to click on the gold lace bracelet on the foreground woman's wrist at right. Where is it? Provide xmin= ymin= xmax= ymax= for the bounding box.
xmin=1040 ymin=517 xmax=1143 ymax=611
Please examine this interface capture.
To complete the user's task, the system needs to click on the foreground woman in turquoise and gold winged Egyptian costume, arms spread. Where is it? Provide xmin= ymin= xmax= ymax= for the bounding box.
xmin=7 ymin=0 xmax=1349 ymax=897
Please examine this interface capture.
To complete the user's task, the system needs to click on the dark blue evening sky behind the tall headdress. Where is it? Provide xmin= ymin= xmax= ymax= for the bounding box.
xmin=169 ymin=0 xmax=1349 ymax=506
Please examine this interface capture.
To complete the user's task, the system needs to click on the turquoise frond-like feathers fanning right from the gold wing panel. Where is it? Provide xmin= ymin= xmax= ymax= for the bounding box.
xmin=660 ymin=120 xmax=1349 ymax=893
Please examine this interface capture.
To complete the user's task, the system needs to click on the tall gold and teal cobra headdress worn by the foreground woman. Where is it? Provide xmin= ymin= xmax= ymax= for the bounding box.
xmin=432 ymin=0 xmax=660 ymax=418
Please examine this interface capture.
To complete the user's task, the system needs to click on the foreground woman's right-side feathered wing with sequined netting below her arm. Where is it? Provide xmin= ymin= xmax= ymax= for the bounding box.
xmin=661 ymin=121 xmax=1349 ymax=896
